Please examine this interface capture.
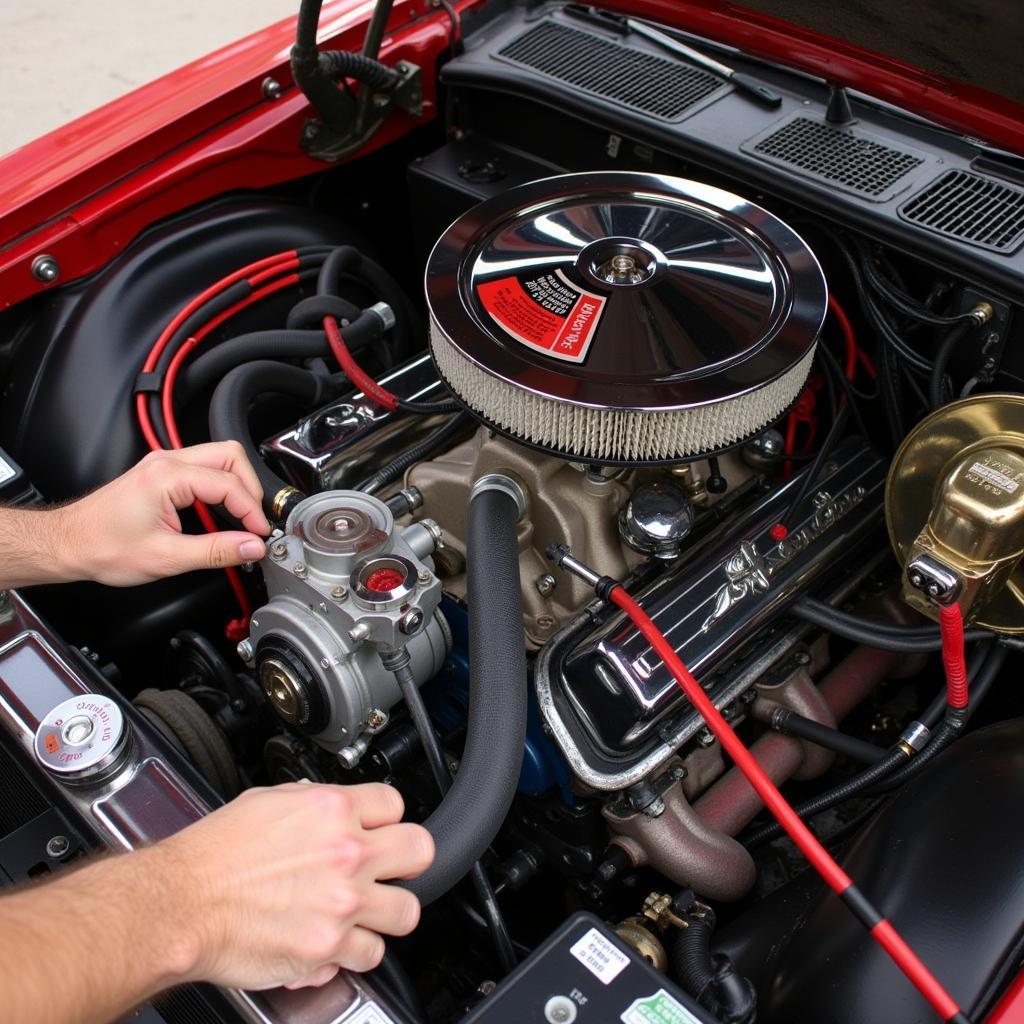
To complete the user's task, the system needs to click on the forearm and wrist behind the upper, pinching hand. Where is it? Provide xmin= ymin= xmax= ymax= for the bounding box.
xmin=0 ymin=506 xmax=84 ymax=588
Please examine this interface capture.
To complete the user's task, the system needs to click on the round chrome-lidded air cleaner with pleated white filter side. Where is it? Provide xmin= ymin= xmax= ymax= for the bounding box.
xmin=426 ymin=171 xmax=826 ymax=464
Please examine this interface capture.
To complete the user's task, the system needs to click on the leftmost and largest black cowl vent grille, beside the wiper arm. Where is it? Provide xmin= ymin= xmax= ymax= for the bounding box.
xmin=498 ymin=22 xmax=724 ymax=121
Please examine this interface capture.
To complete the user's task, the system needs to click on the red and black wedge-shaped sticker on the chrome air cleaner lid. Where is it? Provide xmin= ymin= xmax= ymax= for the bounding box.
xmin=476 ymin=270 xmax=606 ymax=362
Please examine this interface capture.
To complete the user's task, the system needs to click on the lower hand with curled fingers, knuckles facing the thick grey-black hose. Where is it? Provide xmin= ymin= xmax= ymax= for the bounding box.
xmin=146 ymin=782 xmax=434 ymax=989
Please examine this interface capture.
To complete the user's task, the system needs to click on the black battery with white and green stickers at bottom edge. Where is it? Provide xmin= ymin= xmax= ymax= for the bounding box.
xmin=462 ymin=913 xmax=719 ymax=1024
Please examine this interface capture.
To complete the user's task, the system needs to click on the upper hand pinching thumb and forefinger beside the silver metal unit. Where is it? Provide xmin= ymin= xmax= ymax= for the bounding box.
xmin=53 ymin=441 xmax=270 ymax=587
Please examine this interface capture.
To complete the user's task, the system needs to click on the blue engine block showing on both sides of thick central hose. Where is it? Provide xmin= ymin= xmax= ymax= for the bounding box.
xmin=423 ymin=597 xmax=572 ymax=804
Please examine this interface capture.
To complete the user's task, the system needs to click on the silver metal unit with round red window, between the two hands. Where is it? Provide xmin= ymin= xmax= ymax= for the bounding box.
xmin=239 ymin=490 xmax=451 ymax=767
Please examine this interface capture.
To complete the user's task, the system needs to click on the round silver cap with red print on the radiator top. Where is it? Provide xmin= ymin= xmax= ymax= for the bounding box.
xmin=35 ymin=693 xmax=128 ymax=781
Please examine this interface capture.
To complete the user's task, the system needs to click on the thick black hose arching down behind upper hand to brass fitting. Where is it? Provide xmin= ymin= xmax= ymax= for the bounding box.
xmin=210 ymin=359 xmax=335 ymax=515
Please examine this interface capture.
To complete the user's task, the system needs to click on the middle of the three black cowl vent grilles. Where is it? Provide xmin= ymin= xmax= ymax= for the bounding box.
xmin=743 ymin=117 xmax=925 ymax=202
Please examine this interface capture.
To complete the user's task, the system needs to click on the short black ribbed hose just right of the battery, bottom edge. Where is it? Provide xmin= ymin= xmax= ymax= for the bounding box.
xmin=672 ymin=915 xmax=757 ymax=1024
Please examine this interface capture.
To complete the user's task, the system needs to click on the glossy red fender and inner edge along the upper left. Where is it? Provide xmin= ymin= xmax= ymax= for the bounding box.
xmin=0 ymin=0 xmax=452 ymax=309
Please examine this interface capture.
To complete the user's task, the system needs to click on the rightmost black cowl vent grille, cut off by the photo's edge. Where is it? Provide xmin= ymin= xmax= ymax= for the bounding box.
xmin=899 ymin=171 xmax=1024 ymax=253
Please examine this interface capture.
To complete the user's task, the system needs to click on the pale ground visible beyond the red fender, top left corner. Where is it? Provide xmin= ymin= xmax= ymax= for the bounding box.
xmin=0 ymin=0 xmax=299 ymax=154
